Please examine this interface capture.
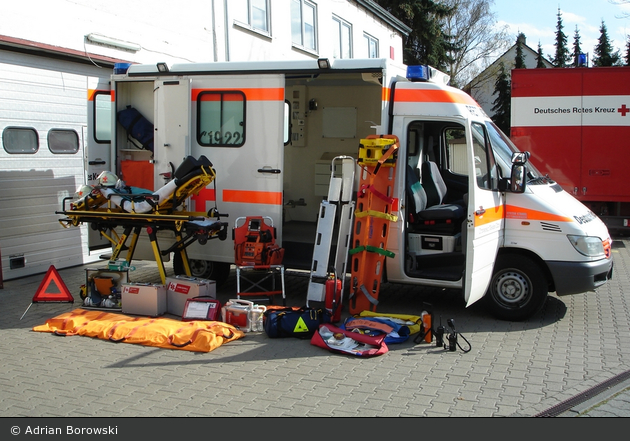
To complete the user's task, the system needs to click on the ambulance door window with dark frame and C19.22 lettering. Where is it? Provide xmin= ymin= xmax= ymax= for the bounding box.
xmin=197 ymin=91 xmax=245 ymax=147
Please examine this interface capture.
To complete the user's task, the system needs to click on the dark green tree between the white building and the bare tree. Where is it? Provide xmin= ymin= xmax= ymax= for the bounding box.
xmin=377 ymin=0 xmax=458 ymax=71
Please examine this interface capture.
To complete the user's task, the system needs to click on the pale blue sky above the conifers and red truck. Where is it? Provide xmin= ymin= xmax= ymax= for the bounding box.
xmin=490 ymin=0 xmax=630 ymax=58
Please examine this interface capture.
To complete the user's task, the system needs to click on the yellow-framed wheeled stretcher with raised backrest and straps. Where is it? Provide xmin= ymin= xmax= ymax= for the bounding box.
xmin=55 ymin=156 xmax=228 ymax=284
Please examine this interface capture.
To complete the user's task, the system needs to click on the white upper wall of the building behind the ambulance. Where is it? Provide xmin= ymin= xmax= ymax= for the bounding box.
xmin=0 ymin=0 xmax=402 ymax=64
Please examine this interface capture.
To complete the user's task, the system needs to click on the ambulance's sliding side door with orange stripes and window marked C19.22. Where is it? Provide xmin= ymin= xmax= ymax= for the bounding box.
xmin=188 ymin=74 xmax=285 ymax=262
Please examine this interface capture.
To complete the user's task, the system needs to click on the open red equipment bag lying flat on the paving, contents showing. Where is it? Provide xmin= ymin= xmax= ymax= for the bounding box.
xmin=311 ymin=323 xmax=389 ymax=357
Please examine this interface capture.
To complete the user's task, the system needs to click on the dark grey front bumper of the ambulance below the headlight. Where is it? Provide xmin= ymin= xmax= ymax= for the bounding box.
xmin=548 ymin=254 xmax=613 ymax=296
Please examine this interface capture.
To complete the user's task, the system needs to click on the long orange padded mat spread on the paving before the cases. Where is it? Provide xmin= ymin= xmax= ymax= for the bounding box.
xmin=33 ymin=309 xmax=245 ymax=352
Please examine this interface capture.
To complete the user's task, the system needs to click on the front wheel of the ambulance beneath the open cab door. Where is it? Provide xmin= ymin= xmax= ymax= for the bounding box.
xmin=485 ymin=255 xmax=548 ymax=321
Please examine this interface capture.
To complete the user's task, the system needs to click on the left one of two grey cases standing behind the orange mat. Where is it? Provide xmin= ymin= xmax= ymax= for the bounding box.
xmin=120 ymin=283 xmax=166 ymax=317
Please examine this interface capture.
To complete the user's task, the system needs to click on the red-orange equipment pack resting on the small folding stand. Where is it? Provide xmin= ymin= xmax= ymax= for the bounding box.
xmin=232 ymin=216 xmax=284 ymax=266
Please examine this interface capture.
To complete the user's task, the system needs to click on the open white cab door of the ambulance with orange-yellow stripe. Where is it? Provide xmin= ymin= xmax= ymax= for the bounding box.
xmin=464 ymin=122 xmax=505 ymax=306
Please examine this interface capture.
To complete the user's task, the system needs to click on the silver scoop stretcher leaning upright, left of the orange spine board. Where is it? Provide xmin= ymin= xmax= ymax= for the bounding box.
xmin=306 ymin=156 xmax=356 ymax=312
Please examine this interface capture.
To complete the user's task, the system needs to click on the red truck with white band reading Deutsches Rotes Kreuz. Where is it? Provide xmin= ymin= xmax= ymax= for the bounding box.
xmin=510 ymin=67 xmax=630 ymax=232
